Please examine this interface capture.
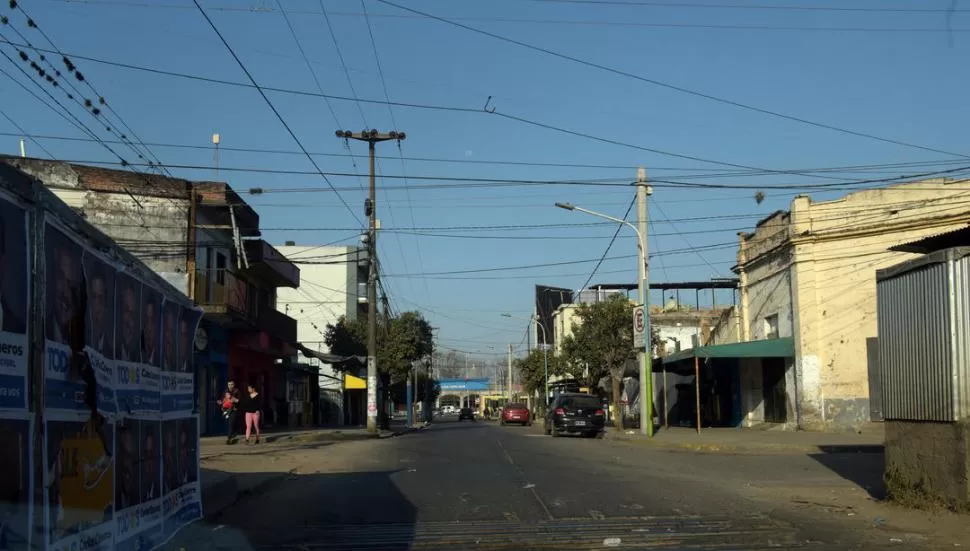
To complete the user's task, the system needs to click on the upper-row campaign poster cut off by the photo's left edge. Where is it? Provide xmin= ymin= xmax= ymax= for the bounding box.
xmin=0 ymin=194 xmax=30 ymax=411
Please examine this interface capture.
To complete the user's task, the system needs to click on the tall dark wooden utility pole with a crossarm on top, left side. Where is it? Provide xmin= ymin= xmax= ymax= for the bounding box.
xmin=337 ymin=129 xmax=407 ymax=432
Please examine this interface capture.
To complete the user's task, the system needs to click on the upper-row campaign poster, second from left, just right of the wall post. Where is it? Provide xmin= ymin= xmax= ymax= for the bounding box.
xmin=44 ymin=223 xmax=90 ymax=412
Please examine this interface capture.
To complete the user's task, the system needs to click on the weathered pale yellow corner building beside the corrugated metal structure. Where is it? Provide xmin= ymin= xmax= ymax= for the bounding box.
xmin=735 ymin=179 xmax=970 ymax=430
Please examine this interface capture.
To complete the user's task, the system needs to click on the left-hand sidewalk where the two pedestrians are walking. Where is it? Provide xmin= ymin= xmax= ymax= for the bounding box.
xmin=199 ymin=422 xmax=420 ymax=518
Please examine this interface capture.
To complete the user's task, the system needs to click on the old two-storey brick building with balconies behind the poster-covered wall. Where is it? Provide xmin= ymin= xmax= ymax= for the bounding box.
xmin=5 ymin=157 xmax=300 ymax=434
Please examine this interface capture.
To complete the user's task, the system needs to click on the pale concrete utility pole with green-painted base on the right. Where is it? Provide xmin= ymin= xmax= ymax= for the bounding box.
xmin=637 ymin=167 xmax=652 ymax=437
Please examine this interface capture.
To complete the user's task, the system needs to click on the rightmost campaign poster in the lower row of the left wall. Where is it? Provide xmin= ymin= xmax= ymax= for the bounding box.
xmin=162 ymin=415 xmax=202 ymax=538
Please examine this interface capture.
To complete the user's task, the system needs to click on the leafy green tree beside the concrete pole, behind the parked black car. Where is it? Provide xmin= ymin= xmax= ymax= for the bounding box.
xmin=562 ymin=295 xmax=637 ymax=429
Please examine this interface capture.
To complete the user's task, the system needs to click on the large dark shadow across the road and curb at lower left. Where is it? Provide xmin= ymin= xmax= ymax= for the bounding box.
xmin=167 ymin=471 xmax=417 ymax=551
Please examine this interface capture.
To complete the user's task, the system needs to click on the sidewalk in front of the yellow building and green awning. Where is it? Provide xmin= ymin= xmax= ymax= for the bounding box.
xmin=607 ymin=423 xmax=885 ymax=453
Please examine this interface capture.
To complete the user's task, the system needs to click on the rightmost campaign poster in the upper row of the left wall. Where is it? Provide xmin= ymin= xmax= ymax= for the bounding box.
xmin=162 ymin=301 xmax=202 ymax=419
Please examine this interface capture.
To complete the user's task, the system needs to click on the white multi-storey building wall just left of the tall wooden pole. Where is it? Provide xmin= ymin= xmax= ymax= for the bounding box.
xmin=276 ymin=246 xmax=367 ymax=386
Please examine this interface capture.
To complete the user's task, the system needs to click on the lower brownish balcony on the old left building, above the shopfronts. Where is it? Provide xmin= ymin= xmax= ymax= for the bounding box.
xmin=195 ymin=269 xmax=296 ymax=343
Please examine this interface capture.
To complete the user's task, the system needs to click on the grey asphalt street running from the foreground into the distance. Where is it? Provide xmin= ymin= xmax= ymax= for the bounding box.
xmin=172 ymin=420 xmax=970 ymax=551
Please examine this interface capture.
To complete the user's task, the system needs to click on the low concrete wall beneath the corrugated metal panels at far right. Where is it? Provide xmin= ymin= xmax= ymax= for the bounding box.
xmin=885 ymin=421 xmax=970 ymax=509
